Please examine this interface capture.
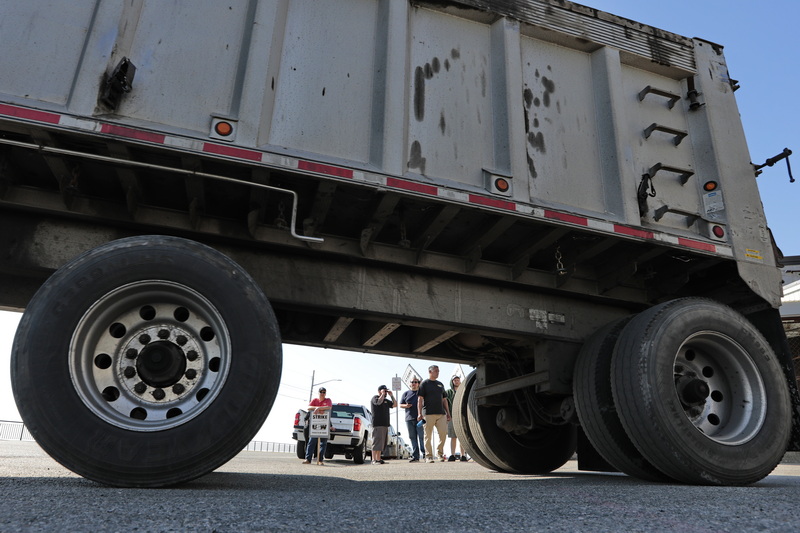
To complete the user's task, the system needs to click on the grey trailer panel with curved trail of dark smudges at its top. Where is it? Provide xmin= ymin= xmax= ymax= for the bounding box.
xmin=406 ymin=9 xmax=493 ymax=187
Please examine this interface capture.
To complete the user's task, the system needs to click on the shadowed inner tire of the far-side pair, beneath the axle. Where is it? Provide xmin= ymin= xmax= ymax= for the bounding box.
xmin=467 ymin=370 xmax=578 ymax=474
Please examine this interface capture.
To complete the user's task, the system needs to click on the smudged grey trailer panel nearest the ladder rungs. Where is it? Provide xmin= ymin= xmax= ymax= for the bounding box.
xmin=520 ymin=37 xmax=605 ymax=213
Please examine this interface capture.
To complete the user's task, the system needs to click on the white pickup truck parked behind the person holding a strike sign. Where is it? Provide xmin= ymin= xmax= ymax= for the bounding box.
xmin=292 ymin=403 xmax=372 ymax=464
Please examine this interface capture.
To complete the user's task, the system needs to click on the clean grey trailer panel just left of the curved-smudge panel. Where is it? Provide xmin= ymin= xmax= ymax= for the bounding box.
xmin=269 ymin=0 xmax=378 ymax=162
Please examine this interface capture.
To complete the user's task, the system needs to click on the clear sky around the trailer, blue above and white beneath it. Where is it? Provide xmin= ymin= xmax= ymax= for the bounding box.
xmin=0 ymin=0 xmax=800 ymax=442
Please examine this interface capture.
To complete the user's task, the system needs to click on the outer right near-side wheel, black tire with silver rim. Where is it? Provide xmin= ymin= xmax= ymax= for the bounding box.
xmin=612 ymin=298 xmax=791 ymax=485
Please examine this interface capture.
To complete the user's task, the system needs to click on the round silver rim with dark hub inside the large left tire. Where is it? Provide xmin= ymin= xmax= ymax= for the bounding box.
xmin=69 ymin=280 xmax=231 ymax=431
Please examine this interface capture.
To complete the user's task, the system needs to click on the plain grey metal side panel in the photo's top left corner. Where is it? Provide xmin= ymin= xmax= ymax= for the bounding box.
xmin=0 ymin=0 xmax=99 ymax=105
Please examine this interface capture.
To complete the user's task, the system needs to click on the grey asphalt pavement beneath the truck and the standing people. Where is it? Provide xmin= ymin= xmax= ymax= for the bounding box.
xmin=0 ymin=441 xmax=800 ymax=533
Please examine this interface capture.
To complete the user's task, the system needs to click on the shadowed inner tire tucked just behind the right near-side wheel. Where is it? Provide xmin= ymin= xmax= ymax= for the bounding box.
xmin=572 ymin=317 xmax=672 ymax=482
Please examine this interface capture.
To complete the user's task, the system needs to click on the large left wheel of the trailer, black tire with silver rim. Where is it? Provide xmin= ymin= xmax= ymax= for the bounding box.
xmin=12 ymin=236 xmax=281 ymax=487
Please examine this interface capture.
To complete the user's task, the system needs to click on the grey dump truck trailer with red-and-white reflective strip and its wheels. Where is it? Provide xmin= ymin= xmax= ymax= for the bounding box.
xmin=0 ymin=0 xmax=800 ymax=487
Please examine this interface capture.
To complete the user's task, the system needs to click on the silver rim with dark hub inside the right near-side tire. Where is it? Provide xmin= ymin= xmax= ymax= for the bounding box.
xmin=674 ymin=331 xmax=767 ymax=446
